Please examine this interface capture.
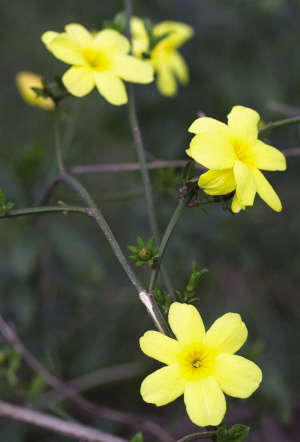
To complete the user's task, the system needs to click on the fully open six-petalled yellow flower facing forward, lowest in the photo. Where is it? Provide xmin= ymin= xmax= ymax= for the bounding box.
xmin=140 ymin=302 xmax=262 ymax=427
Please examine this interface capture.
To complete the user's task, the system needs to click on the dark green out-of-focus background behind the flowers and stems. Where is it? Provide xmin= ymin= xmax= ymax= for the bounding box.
xmin=0 ymin=0 xmax=300 ymax=442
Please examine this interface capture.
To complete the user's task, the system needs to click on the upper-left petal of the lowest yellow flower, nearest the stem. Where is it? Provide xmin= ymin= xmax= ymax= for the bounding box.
xmin=140 ymin=331 xmax=182 ymax=365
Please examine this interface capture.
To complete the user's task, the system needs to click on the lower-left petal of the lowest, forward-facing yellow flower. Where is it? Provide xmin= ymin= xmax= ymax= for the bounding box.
xmin=141 ymin=364 xmax=186 ymax=407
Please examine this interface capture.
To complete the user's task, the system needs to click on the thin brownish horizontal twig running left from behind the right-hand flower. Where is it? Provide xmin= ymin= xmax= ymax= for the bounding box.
xmin=71 ymin=160 xmax=205 ymax=174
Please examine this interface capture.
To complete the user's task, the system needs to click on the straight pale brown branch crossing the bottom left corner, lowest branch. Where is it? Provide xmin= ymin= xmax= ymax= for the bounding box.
xmin=0 ymin=401 xmax=128 ymax=442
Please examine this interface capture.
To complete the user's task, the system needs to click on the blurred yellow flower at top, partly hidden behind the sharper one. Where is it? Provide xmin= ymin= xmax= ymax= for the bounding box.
xmin=131 ymin=17 xmax=194 ymax=97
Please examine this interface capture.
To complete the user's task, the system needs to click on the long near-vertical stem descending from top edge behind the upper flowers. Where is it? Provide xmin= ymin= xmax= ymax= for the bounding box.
xmin=125 ymin=0 xmax=175 ymax=301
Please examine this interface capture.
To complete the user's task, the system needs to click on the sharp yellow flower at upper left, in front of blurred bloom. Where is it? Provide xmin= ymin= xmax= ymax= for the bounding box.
xmin=42 ymin=24 xmax=153 ymax=105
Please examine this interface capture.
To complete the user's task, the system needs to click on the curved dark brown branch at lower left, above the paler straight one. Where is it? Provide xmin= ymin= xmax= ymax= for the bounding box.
xmin=0 ymin=315 xmax=174 ymax=442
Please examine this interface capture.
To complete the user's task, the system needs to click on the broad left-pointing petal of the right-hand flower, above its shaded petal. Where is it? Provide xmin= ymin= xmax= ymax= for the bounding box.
xmin=186 ymin=133 xmax=238 ymax=170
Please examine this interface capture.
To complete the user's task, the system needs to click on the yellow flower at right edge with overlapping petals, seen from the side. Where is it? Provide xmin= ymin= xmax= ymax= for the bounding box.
xmin=186 ymin=106 xmax=286 ymax=212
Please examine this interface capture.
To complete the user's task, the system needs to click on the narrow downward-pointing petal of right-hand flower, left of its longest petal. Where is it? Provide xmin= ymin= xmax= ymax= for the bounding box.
xmin=233 ymin=161 xmax=256 ymax=206
